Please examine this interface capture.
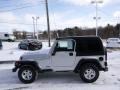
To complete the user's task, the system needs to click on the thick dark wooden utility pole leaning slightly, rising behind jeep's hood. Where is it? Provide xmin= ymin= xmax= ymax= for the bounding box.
xmin=45 ymin=0 xmax=51 ymax=47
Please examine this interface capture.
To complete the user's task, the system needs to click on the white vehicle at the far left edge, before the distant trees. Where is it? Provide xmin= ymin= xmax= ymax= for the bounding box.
xmin=0 ymin=32 xmax=16 ymax=42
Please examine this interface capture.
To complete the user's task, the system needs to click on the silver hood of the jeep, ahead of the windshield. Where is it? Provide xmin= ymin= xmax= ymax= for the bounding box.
xmin=21 ymin=48 xmax=50 ymax=61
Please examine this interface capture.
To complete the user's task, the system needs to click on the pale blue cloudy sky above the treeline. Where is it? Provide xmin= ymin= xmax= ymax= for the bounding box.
xmin=0 ymin=0 xmax=120 ymax=32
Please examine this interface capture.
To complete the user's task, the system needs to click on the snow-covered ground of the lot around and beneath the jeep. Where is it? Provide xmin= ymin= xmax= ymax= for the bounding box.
xmin=0 ymin=42 xmax=120 ymax=90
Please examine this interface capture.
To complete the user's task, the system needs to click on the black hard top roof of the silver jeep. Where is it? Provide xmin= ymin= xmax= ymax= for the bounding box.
xmin=57 ymin=36 xmax=104 ymax=56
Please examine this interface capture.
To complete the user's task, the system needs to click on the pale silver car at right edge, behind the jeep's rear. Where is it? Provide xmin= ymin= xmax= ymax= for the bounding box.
xmin=106 ymin=38 xmax=120 ymax=48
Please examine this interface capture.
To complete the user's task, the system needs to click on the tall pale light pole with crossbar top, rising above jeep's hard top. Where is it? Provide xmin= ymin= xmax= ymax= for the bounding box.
xmin=91 ymin=0 xmax=103 ymax=36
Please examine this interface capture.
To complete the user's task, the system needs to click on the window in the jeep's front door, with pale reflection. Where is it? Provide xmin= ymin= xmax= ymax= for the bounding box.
xmin=56 ymin=40 xmax=74 ymax=51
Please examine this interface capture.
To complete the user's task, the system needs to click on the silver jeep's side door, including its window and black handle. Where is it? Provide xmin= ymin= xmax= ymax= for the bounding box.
xmin=52 ymin=39 xmax=76 ymax=70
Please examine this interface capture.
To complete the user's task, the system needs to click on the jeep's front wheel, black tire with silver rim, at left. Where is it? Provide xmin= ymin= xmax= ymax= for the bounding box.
xmin=18 ymin=66 xmax=37 ymax=84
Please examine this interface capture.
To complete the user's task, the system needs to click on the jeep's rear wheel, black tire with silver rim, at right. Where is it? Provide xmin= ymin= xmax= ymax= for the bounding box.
xmin=79 ymin=63 xmax=99 ymax=83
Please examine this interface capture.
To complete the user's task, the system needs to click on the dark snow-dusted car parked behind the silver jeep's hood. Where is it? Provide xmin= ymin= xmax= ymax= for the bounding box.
xmin=18 ymin=39 xmax=42 ymax=50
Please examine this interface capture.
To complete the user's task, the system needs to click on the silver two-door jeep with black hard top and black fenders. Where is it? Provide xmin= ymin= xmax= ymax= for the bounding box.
xmin=13 ymin=36 xmax=108 ymax=83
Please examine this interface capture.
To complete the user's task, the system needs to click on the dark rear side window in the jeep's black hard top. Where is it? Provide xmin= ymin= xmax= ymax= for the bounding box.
xmin=76 ymin=38 xmax=103 ymax=56
